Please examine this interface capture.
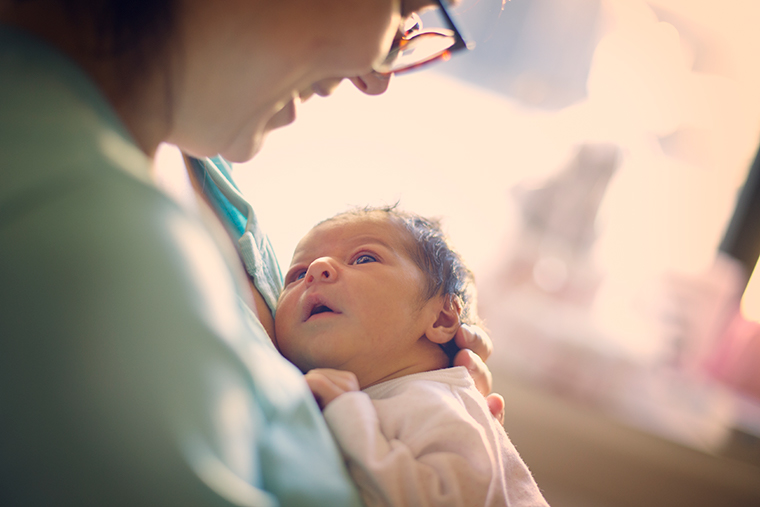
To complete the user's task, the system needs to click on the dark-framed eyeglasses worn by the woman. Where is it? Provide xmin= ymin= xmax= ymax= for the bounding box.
xmin=375 ymin=0 xmax=475 ymax=74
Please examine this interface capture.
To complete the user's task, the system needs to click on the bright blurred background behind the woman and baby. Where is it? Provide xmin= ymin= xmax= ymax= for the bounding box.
xmin=159 ymin=0 xmax=760 ymax=507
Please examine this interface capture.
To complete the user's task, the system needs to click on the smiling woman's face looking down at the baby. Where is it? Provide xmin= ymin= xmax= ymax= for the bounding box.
xmin=168 ymin=0 xmax=401 ymax=161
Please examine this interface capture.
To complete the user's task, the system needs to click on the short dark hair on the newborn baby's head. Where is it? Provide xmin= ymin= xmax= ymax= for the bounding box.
xmin=320 ymin=203 xmax=480 ymax=325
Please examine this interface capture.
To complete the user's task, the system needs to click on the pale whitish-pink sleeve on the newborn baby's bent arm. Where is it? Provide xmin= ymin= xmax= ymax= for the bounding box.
xmin=324 ymin=386 xmax=496 ymax=506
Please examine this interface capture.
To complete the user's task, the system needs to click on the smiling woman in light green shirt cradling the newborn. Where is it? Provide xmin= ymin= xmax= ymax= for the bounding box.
xmin=0 ymin=0 xmax=498 ymax=506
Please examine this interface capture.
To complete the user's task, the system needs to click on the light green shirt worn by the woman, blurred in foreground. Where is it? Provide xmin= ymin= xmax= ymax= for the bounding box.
xmin=0 ymin=23 xmax=360 ymax=506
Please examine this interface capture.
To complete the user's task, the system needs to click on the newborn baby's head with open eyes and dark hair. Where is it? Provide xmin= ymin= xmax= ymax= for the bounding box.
xmin=275 ymin=207 xmax=477 ymax=387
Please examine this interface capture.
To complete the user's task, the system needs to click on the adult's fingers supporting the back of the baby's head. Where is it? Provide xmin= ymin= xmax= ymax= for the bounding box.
xmin=453 ymin=324 xmax=504 ymax=424
